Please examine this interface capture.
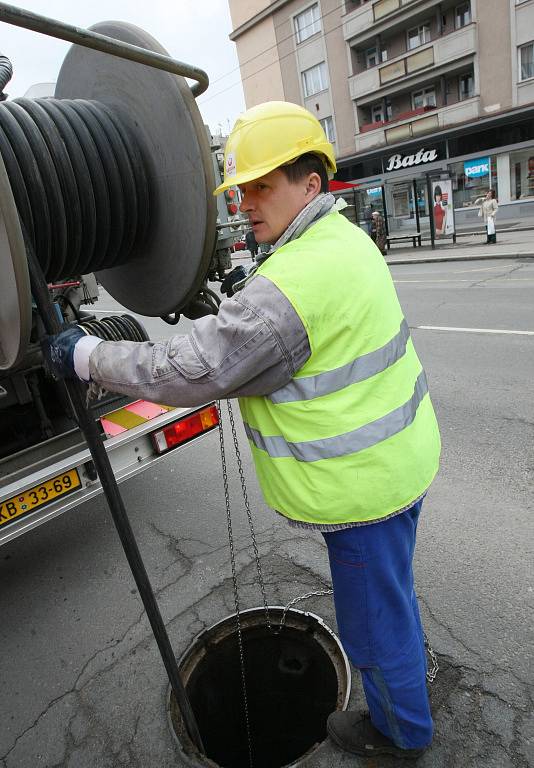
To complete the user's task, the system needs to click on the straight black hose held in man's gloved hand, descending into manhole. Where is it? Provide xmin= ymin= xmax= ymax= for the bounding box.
xmin=26 ymin=238 xmax=205 ymax=754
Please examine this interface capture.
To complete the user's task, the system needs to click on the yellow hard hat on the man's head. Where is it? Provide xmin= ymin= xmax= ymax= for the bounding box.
xmin=213 ymin=101 xmax=336 ymax=195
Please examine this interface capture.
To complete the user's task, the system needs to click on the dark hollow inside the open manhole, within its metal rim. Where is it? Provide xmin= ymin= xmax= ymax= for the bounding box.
xmin=172 ymin=626 xmax=338 ymax=768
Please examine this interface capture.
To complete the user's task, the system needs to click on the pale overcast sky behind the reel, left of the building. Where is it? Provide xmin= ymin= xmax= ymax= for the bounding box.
xmin=0 ymin=0 xmax=245 ymax=133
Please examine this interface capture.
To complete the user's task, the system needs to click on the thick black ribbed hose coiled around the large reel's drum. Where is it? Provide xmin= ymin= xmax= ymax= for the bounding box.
xmin=0 ymin=99 xmax=150 ymax=281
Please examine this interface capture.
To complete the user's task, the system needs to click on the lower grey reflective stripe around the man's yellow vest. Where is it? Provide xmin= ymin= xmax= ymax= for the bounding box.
xmin=245 ymin=370 xmax=428 ymax=461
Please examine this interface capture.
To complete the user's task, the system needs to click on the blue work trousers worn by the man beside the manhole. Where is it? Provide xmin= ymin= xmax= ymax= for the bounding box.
xmin=323 ymin=501 xmax=432 ymax=749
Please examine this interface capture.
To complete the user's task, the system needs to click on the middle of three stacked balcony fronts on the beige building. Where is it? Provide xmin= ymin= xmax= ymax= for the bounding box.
xmin=349 ymin=23 xmax=476 ymax=103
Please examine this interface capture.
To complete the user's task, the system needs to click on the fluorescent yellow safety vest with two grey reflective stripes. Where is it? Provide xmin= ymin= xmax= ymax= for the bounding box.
xmin=239 ymin=212 xmax=440 ymax=524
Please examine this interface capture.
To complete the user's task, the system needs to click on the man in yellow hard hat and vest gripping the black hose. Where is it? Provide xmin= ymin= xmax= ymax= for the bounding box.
xmin=48 ymin=102 xmax=440 ymax=758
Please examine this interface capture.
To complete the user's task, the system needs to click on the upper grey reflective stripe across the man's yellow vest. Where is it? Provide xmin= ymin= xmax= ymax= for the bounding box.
xmin=268 ymin=319 xmax=410 ymax=403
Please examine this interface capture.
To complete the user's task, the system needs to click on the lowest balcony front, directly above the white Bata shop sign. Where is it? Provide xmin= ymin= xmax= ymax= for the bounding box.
xmin=355 ymin=96 xmax=480 ymax=152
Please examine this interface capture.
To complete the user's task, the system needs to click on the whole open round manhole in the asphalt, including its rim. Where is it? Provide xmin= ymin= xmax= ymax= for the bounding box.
xmin=168 ymin=606 xmax=350 ymax=768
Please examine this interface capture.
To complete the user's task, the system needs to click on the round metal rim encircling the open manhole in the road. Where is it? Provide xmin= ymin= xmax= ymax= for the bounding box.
xmin=165 ymin=605 xmax=352 ymax=768
